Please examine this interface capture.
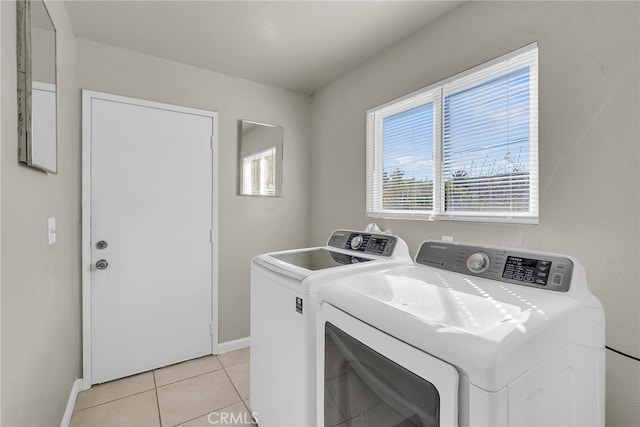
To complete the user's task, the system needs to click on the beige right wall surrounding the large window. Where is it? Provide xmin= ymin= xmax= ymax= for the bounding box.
xmin=311 ymin=2 xmax=640 ymax=426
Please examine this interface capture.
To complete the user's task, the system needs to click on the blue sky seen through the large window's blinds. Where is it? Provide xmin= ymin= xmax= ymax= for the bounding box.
xmin=382 ymin=67 xmax=530 ymax=186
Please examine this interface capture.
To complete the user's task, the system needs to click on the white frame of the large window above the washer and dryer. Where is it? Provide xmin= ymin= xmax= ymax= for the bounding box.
xmin=366 ymin=42 xmax=539 ymax=224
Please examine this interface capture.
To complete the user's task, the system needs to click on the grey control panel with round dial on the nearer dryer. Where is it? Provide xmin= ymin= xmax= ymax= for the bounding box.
xmin=416 ymin=241 xmax=573 ymax=292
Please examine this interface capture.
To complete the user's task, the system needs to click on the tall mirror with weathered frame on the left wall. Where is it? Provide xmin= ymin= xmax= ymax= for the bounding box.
xmin=17 ymin=0 xmax=58 ymax=173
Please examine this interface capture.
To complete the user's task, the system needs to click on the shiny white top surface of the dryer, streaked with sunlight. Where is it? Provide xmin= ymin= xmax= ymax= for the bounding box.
xmin=318 ymin=265 xmax=604 ymax=391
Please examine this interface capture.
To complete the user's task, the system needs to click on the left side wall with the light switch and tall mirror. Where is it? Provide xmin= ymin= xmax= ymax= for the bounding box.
xmin=0 ymin=1 xmax=82 ymax=426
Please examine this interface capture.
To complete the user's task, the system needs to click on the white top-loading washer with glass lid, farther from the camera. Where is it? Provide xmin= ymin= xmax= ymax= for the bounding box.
xmin=250 ymin=230 xmax=412 ymax=427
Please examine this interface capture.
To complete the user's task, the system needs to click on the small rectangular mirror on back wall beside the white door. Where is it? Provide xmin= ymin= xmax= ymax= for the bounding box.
xmin=238 ymin=120 xmax=284 ymax=196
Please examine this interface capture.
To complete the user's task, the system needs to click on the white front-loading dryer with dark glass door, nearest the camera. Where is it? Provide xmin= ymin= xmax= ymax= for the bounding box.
xmin=316 ymin=241 xmax=605 ymax=427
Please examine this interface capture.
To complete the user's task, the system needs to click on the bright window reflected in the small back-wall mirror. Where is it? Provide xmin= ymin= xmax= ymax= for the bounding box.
xmin=242 ymin=147 xmax=276 ymax=196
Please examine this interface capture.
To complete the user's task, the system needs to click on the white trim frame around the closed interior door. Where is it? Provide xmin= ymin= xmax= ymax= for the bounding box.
xmin=81 ymin=89 xmax=219 ymax=390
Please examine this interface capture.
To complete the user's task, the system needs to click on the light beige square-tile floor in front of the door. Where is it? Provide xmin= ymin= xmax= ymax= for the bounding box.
xmin=70 ymin=348 xmax=253 ymax=427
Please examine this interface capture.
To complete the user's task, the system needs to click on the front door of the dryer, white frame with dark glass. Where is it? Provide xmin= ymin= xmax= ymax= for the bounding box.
xmin=319 ymin=306 xmax=458 ymax=427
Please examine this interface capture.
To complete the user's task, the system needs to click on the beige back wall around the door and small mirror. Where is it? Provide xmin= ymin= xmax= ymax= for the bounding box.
xmin=77 ymin=39 xmax=310 ymax=342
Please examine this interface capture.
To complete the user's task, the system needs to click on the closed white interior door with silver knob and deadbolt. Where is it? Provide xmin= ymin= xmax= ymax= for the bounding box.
xmin=83 ymin=93 xmax=216 ymax=384
